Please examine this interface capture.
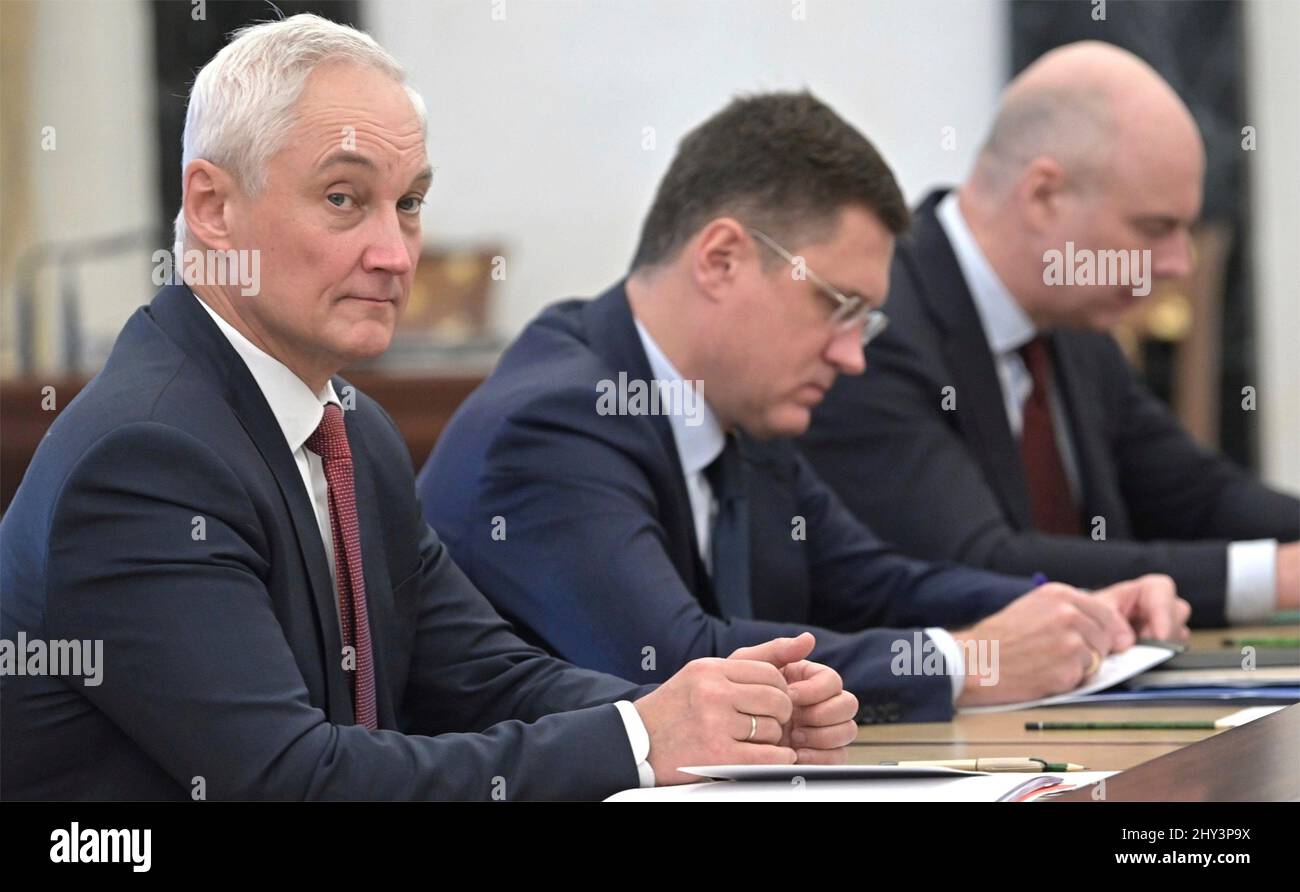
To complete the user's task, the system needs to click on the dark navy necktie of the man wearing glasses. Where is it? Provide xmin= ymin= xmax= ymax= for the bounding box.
xmin=705 ymin=434 xmax=754 ymax=619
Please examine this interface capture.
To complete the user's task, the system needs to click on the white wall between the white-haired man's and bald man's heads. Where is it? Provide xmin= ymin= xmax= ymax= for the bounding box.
xmin=365 ymin=0 xmax=1006 ymax=335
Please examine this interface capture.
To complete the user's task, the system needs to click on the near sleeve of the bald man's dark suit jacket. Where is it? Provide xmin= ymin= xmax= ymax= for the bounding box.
xmin=801 ymin=325 xmax=1294 ymax=625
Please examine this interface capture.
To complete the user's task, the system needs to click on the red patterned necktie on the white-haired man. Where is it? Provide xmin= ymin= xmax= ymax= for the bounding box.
xmin=307 ymin=403 xmax=380 ymax=728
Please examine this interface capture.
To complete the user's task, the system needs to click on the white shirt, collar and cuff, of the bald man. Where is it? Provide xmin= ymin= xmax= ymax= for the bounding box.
xmin=935 ymin=191 xmax=1278 ymax=623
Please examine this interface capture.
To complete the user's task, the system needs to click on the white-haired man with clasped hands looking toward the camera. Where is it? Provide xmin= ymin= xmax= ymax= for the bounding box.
xmin=0 ymin=16 xmax=857 ymax=800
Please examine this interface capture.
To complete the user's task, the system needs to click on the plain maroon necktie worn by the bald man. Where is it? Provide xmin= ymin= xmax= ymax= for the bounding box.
xmin=1021 ymin=337 xmax=1083 ymax=536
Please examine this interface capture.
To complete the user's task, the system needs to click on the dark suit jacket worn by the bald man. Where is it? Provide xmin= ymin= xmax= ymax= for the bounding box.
xmin=800 ymin=192 xmax=1300 ymax=625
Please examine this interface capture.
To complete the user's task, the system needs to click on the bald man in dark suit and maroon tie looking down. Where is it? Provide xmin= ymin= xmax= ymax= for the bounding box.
xmin=802 ymin=42 xmax=1300 ymax=625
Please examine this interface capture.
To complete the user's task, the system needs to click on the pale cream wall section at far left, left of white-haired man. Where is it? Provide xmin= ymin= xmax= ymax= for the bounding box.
xmin=0 ymin=0 xmax=160 ymax=371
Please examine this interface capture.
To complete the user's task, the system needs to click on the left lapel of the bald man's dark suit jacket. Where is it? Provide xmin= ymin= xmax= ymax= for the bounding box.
xmin=910 ymin=192 xmax=1034 ymax=528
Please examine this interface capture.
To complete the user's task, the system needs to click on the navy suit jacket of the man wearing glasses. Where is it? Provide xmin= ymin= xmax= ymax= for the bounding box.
xmin=417 ymin=285 xmax=1030 ymax=722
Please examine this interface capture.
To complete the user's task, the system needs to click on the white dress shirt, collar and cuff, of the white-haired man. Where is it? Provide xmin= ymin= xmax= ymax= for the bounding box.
xmin=195 ymin=295 xmax=654 ymax=787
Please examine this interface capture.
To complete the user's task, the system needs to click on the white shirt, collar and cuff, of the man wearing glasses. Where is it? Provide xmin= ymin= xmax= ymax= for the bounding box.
xmin=633 ymin=319 xmax=966 ymax=701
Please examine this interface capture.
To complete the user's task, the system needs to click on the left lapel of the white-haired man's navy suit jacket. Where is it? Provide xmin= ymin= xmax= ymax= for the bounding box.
xmin=150 ymin=285 xmax=354 ymax=724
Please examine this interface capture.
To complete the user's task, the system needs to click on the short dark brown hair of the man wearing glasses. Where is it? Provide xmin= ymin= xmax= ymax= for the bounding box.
xmin=632 ymin=91 xmax=909 ymax=272
